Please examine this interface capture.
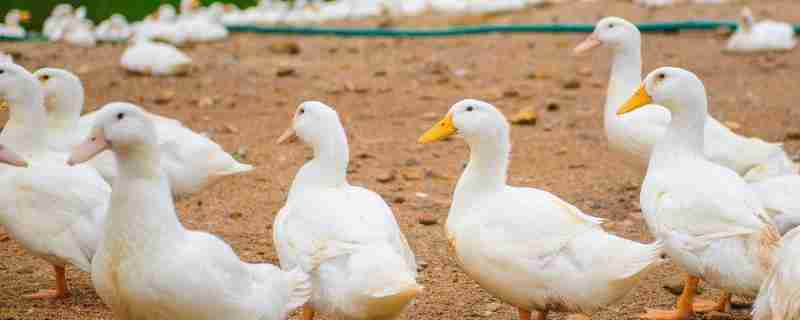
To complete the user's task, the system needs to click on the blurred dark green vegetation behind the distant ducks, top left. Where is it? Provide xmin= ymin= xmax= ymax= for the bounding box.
xmin=0 ymin=0 xmax=258 ymax=30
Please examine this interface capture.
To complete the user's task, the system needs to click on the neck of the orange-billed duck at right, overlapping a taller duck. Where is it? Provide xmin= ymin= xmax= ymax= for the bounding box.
xmin=650 ymin=95 xmax=708 ymax=168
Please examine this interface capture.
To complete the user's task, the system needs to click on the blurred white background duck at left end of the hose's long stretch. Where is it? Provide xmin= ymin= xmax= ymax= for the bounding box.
xmin=177 ymin=0 xmax=228 ymax=42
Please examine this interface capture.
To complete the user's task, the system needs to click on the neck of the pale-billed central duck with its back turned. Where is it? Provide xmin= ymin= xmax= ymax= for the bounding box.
xmin=289 ymin=126 xmax=350 ymax=197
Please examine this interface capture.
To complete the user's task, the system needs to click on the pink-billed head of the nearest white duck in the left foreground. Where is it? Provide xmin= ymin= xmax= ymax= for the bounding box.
xmin=67 ymin=102 xmax=156 ymax=165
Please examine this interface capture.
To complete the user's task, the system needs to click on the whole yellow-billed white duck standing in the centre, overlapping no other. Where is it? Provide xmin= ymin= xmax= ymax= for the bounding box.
xmin=419 ymin=100 xmax=661 ymax=320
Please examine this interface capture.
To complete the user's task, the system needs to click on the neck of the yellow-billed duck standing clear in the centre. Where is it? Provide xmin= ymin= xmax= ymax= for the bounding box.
xmin=453 ymin=130 xmax=511 ymax=205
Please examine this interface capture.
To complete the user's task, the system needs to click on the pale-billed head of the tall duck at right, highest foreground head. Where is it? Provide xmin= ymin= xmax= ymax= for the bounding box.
xmin=573 ymin=17 xmax=641 ymax=55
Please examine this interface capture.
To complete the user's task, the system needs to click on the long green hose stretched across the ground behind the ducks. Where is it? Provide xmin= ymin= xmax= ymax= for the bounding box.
xmin=0 ymin=20 xmax=800 ymax=41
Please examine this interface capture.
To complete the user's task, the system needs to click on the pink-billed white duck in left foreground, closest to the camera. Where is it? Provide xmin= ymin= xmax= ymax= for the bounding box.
xmin=69 ymin=103 xmax=311 ymax=320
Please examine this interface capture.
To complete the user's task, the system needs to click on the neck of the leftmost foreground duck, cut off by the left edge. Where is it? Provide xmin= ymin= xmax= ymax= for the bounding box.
xmin=0 ymin=83 xmax=47 ymax=157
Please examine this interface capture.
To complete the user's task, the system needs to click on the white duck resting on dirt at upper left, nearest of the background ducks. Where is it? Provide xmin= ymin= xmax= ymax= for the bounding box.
xmin=119 ymin=35 xmax=192 ymax=76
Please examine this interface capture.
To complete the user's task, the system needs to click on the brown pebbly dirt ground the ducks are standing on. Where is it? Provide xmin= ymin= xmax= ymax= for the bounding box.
xmin=0 ymin=0 xmax=800 ymax=320
